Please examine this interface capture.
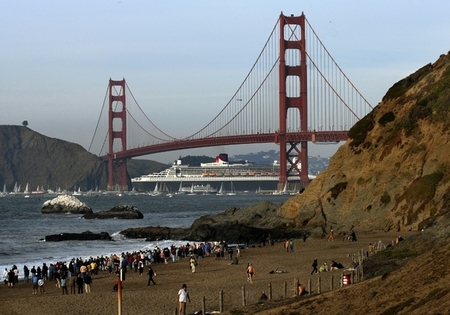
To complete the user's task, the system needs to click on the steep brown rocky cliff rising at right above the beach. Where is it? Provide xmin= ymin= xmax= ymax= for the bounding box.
xmin=277 ymin=54 xmax=450 ymax=234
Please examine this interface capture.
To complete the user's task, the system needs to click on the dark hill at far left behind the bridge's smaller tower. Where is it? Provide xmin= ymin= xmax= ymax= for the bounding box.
xmin=0 ymin=125 xmax=107 ymax=191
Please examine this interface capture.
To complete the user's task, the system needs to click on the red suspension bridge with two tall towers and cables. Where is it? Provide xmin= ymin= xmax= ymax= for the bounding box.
xmin=89 ymin=13 xmax=372 ymax=190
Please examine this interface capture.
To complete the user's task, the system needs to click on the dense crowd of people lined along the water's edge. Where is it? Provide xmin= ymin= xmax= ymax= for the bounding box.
xmin=3 ymin=241 xmax=240 ymax=294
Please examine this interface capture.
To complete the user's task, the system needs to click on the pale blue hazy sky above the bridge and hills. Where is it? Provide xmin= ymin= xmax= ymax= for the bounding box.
xmin=0 ymin=0 xmax=450 ymax=163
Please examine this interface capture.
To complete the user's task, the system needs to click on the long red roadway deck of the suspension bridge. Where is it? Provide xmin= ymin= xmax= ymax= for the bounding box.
xmin=102 ymin=131 xmax=348 ymax=160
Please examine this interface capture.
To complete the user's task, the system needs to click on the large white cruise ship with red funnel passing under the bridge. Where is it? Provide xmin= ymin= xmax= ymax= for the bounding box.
xmin=131 ymin=153 xmax=306 ymax=193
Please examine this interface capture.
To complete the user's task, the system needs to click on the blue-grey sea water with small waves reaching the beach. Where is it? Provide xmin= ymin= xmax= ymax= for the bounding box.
xmin=0 ymin=193 xmax=289 ymax=277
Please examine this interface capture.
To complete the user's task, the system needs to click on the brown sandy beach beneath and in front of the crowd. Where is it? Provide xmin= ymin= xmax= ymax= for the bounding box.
xmin=0 ymin=232 xmax=405 ymax=315
